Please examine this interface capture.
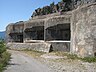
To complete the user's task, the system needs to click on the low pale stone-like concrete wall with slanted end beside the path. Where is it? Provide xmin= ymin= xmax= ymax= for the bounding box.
xmin=6 ymin=43 xmax=51 ymax=52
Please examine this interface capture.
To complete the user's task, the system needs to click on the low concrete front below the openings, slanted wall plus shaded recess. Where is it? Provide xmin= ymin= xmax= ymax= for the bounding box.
xmin=6 ymin=42 xmax=70 ymax=53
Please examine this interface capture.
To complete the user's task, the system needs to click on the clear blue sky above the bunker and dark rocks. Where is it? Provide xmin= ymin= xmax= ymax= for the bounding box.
xmin=0 ymin=0 xmax=61 ymax=31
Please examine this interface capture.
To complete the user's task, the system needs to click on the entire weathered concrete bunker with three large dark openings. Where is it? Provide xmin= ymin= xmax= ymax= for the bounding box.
xmin=6 ymin=3 xmax=96 ymax=57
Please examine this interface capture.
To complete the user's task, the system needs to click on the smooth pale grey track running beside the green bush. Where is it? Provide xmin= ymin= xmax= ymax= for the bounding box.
xmin=4 ymin=51 xmax=53 ymax=72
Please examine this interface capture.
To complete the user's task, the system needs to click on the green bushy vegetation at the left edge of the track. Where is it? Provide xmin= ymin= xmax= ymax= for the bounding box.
xmin=0 ymin=41 xmax=11 ymax=72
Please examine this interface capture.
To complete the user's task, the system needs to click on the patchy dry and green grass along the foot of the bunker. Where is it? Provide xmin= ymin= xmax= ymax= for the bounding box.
xmin=23 ymin=50 xmax=96 ymax=62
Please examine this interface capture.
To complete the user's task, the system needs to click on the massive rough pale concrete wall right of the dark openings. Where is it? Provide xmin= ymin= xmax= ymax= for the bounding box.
xmin=71 ymin=3 xmax=96 ymax=57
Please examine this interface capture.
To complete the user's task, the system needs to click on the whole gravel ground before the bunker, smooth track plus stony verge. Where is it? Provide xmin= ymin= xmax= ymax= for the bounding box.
xmin=4 ymin=51 xmax=96 ymax=72
